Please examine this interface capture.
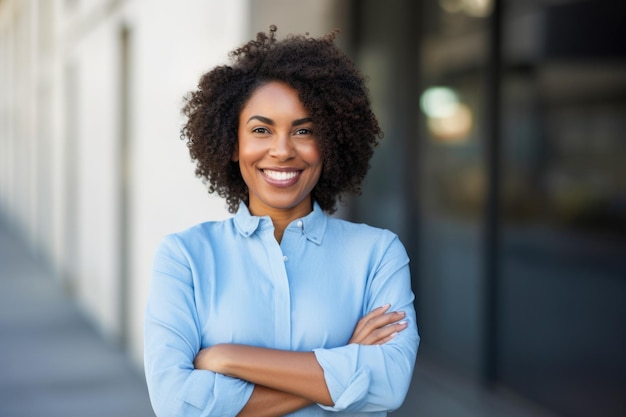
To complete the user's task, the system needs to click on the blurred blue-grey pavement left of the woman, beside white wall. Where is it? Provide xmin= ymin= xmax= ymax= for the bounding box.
xmin=0 ymin=223 xmax=154 ymax=417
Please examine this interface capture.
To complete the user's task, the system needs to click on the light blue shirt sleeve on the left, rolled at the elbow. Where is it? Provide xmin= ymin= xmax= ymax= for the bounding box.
xmin=144 ymin=236 xmax=253 ymax=417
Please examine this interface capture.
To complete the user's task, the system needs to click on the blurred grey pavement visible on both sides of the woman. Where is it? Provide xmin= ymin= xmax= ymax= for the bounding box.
xmin=0 ymin=222 xmax=554 ymax=417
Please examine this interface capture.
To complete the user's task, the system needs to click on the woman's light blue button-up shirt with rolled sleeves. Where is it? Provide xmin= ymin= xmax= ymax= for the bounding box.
xmin=144 ymin=204 xmax=419 ymax=417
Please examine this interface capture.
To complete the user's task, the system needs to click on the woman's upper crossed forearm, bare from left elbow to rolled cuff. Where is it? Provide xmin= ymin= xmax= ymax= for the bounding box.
xmin=194 ymin=344 xmax=333 ymax=405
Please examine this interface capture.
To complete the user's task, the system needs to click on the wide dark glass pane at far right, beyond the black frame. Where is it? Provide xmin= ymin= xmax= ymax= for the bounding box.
xmin=498 ymin=0 xmax=626 ymax=416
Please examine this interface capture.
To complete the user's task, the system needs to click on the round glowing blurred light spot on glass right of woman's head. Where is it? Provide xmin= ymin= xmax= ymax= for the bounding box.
xmin=420 ymin=86 xmax=473 ymax=143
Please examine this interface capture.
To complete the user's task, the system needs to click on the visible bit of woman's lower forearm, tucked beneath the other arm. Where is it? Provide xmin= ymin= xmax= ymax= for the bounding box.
xmin=237 ymin=385 xmax=313 ymax=417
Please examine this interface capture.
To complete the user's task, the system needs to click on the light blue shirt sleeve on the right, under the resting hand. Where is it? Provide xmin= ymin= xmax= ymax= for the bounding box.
xmin=314 ymin=237 xmax=420 ymax=412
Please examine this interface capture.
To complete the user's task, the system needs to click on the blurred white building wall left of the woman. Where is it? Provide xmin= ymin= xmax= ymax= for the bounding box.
xmin=0 ymin=0 xmax=248 ymax=364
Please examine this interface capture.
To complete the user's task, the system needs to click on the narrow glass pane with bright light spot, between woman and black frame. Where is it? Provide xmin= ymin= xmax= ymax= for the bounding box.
xmin=416 ymin=0 xmax=490 ymax=377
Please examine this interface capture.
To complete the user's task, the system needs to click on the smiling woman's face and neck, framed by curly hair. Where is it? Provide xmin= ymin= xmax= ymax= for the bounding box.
xmin=233 ymin=81 xmax=322 ymax=218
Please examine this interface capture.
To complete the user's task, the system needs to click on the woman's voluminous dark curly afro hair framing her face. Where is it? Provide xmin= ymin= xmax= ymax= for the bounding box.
xmin=181 ymin=25 xmax=382 ymax=213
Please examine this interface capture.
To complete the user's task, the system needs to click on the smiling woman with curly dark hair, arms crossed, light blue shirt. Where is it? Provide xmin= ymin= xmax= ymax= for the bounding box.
xmin=145 ymin=26 xmax=419 ymax=417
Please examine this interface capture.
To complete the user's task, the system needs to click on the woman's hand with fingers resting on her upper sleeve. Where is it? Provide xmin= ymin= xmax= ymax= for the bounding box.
xmin=348 ymin=304 xmax=408 ymax=345
